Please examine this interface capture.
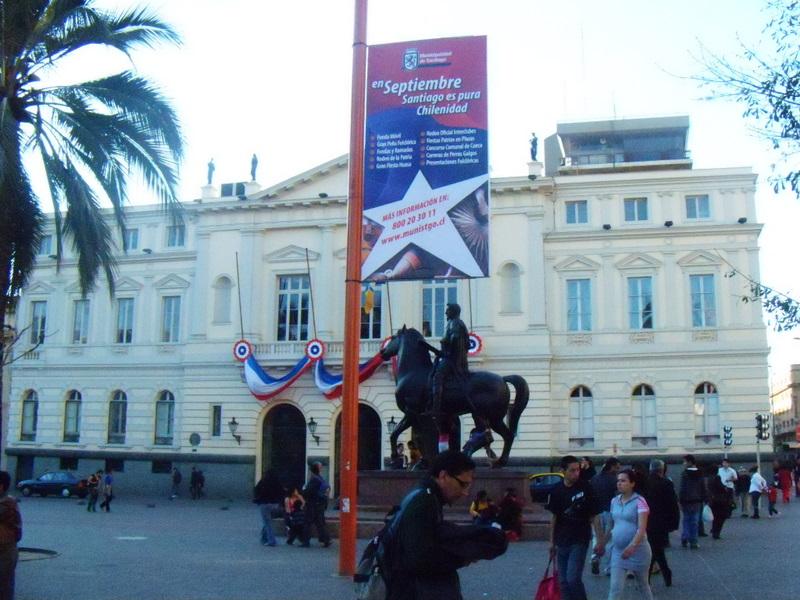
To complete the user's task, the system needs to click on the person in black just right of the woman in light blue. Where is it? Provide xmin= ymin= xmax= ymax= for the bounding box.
xmin=643 ymin=458 xmax=681 ymax=587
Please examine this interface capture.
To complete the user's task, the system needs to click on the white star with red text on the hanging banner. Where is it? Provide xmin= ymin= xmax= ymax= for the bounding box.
xmin=361 ymin=171 xmax=489 ymax=279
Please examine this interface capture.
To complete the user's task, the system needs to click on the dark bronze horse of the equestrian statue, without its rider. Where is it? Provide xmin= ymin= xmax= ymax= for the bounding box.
xmin=381 ymin=325 xmax=529 ymax=467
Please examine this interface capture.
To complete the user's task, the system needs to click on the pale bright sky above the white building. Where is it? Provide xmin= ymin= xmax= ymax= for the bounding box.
xmin=29 ymin=0 xmax=800 ymax=380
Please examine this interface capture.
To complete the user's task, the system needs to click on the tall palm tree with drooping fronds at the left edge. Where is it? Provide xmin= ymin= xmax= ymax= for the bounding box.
xmin=0 ymin=0 xmax=183 ymax=450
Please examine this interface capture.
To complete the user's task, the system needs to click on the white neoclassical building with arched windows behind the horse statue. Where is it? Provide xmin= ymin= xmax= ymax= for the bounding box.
xmin=6 ymin=117 xmax=769 ymax=495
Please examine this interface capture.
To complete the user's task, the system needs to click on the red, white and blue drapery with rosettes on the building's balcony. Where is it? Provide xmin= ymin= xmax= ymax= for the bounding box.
xmin=233 ymin=339 xmax=384 ymax=400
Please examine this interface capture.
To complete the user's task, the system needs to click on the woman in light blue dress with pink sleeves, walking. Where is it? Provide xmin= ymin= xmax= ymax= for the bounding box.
xmin=608 ymin=469 xmax=653 ymax=600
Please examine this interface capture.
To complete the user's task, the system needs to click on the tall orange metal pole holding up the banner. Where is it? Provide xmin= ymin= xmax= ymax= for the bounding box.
xmin=339 ymin=0 xmax=367 ymax=575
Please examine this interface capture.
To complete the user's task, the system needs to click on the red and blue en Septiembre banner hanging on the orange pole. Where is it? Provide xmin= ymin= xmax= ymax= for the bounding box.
xmin=361 ymin=37 xmax=489 ymax=281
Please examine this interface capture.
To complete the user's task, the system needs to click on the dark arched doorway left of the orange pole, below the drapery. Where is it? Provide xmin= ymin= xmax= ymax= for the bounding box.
xmin=261 ymin=404 xmax=306 ymax=486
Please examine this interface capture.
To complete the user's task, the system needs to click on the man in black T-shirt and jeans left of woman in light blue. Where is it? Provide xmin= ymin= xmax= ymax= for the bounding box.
xmin=545 ymin=455 xmax=605 ymax=600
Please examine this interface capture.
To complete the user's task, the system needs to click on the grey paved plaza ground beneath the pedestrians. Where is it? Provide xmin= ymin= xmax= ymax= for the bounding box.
xmin=17 ymin=497 xmax=800 ymax=600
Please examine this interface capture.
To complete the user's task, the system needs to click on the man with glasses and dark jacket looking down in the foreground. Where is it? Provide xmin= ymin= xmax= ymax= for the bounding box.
xmin=387 ymin=450 xmax=488 ymax=600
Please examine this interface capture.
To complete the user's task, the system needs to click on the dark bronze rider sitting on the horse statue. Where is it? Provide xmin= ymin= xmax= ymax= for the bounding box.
xmin=429 ymin=304 xmax=469 ymax=418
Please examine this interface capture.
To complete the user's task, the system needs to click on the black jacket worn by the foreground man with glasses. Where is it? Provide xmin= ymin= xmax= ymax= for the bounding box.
xmin=387 ymin=478 xmax=467 ymax=600
